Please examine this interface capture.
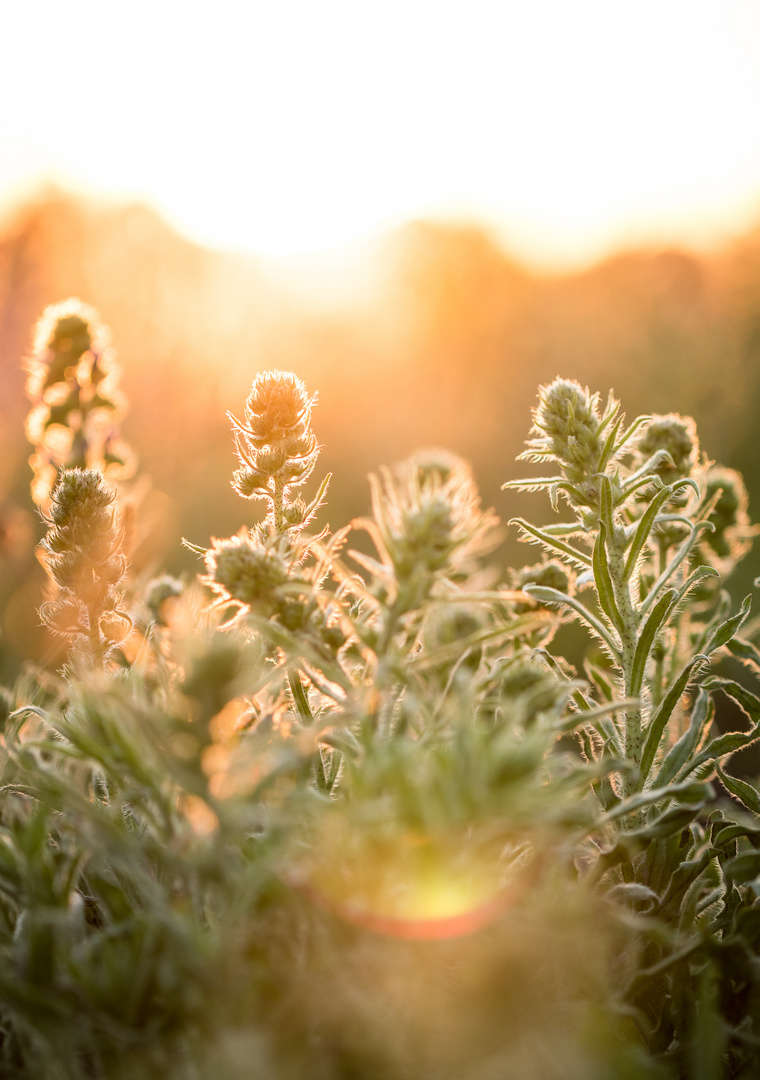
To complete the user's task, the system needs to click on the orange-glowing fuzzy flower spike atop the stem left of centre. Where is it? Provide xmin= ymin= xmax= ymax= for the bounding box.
xmin=228 ymin=370 xmax=329 ymax=537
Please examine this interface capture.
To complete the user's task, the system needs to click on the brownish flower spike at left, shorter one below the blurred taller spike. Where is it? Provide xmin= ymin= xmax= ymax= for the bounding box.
xmin=40 ymin=469 xmax=132 ymax=666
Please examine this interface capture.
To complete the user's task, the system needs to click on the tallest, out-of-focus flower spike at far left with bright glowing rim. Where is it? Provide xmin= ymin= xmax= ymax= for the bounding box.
xmin=26 ymin=297 xmax=133 ymax=511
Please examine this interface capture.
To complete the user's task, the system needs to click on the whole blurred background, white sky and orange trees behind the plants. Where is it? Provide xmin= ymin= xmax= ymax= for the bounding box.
xmin=0 ymin=0 xmax=760 ymax=678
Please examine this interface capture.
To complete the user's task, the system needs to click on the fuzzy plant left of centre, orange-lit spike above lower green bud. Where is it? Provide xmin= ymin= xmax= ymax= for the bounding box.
xmin=201 ymin=372 xmax=349 ymax=786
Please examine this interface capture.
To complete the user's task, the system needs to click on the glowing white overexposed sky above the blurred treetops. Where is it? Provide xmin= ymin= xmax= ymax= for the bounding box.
xmin=0 ymin=0 xmax=760 ymax=262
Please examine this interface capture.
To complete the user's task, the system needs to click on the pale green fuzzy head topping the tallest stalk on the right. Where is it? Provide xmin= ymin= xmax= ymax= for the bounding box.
xmin=520 ymin=379 xmax=616 ymax=484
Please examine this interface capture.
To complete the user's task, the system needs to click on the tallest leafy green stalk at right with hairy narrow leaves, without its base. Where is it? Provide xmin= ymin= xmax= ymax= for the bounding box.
xmin=505 ymin=379 xmax=718 ymax=795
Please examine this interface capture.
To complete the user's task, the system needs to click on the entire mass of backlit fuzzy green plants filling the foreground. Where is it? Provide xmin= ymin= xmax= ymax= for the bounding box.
xmin=0 ymin=302 xmax=760 ymax=1080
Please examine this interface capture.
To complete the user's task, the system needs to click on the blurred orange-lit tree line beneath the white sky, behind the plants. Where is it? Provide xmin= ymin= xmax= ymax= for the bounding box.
xmin=0 ymin=190 xmax=760 ymax=678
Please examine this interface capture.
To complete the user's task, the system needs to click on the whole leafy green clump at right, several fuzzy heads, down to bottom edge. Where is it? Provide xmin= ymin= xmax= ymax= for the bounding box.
xmin=505 ymin=379 xmax=760 ymax=1077
